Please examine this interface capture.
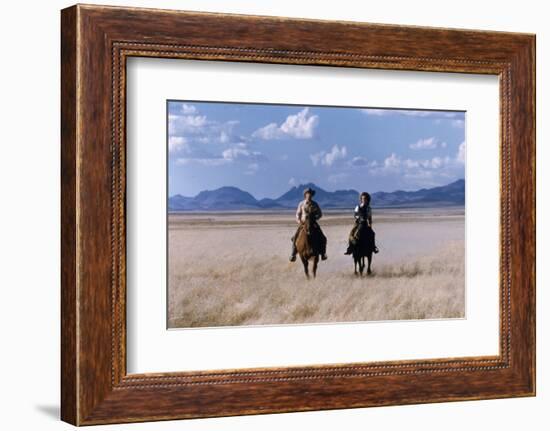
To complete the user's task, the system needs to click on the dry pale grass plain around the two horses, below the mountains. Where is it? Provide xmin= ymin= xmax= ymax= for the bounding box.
xmin=168 ymin=208 xmax=465 ymax=328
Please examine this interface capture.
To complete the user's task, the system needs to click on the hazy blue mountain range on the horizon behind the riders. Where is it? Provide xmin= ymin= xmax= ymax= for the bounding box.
xmin=168 ymin=180 xmax=464 ymax=211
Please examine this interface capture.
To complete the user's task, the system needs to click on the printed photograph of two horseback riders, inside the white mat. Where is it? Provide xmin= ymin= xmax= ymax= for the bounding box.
xmin=167 ymin=100 xmax=466 ymax=328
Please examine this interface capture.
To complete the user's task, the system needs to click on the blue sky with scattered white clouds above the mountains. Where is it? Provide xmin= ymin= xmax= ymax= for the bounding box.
xmin=168 ymin=101 xmax=465 ymax=199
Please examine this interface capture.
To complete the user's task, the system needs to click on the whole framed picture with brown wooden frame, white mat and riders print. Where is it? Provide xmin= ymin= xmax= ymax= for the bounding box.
xmin=61 ymin=5 xmax=535 ymax=425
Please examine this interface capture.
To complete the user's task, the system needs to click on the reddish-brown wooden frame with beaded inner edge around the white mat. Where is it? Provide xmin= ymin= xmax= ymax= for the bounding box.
xmin=61 ymin=5 xmax=535 ymax=425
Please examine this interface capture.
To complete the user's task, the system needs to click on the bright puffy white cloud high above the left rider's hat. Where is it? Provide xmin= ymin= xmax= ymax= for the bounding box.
xmin=252 ymin=108 xmax=319 ymax=140
